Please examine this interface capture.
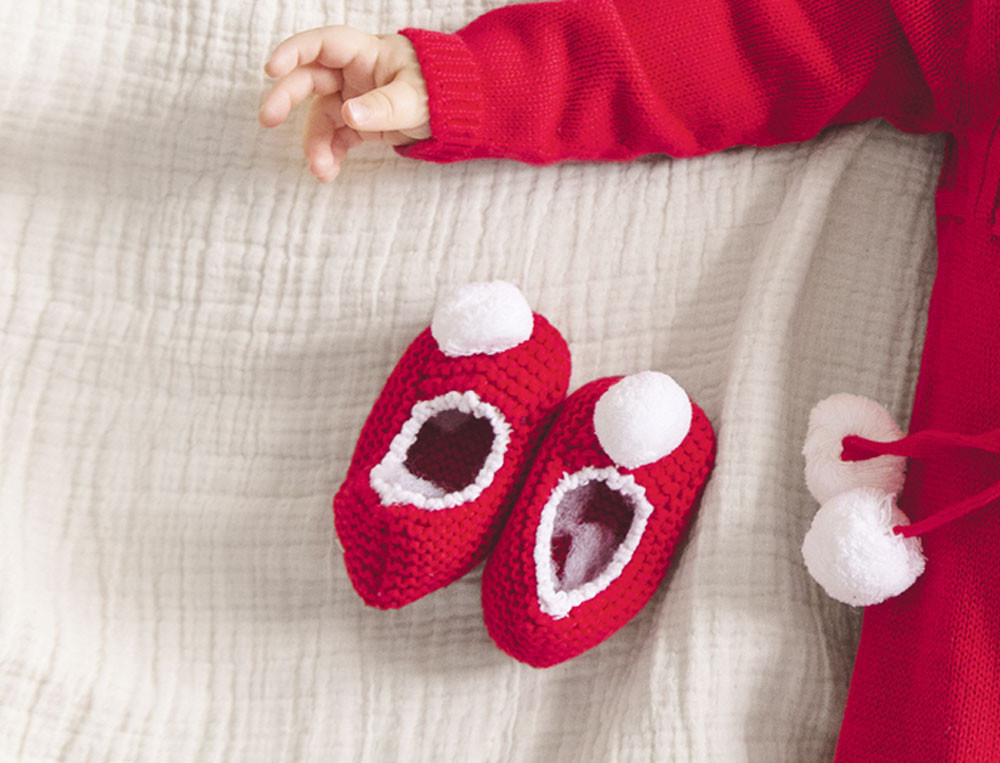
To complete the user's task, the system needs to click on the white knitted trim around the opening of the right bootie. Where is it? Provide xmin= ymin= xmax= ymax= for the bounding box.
xmin=535 ymin=466 xmax=653 ymax=620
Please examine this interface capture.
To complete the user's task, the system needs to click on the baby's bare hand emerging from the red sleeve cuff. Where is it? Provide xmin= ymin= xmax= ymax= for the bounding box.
xmin=258 ymin=26 xmax=431 ymax=183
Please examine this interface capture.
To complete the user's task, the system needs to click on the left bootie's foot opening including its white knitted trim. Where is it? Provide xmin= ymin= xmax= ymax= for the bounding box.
xmin=370 ymin=391 xmax=511 ymax=509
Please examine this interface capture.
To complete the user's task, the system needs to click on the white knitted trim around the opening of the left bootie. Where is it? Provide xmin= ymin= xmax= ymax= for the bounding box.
xmin=369 ymin=390 xmax=511 ymax=510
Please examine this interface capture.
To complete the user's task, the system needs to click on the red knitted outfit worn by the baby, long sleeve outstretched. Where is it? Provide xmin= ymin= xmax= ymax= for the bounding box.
xmin=398 ymin=0 xmax=1000 ymax=763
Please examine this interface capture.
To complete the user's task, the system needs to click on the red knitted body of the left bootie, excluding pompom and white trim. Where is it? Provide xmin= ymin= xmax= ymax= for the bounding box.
xmin=333 ymin=314 xmax=570 ymax=609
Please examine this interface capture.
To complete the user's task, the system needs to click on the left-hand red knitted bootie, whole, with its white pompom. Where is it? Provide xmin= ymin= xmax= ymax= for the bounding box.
xmin=333 ymin=281 xmax=570 ymax=609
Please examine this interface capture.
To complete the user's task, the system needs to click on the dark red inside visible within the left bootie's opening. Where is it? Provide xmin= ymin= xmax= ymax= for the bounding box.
xmin=403 ymin=410 xmax=494 ymax=493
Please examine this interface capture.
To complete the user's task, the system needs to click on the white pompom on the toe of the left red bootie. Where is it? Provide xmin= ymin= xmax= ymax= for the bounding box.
xmin=431 ymin=281 xmax=535 ymax=357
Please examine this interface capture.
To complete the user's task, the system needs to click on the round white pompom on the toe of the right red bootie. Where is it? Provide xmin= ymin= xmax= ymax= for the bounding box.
xmin=594 ymin=371 xmax=692 ymax=469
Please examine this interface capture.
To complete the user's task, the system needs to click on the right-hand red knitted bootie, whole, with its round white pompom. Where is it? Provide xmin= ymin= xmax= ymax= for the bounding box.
xmin=482 ymin=372 xmax=715 ymax=667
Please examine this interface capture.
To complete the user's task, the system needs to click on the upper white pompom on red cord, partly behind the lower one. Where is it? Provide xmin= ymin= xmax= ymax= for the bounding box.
xmin=802 ymin=394 xmax=906 ymax=503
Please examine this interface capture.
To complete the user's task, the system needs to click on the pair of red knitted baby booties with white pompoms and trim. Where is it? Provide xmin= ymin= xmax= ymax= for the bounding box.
xmin=333 ymin=281 xmax=715 ymax=667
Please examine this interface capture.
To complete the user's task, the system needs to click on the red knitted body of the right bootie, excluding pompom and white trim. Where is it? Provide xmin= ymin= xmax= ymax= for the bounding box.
xmin=482 ymin=377 xmax=715 ymax=667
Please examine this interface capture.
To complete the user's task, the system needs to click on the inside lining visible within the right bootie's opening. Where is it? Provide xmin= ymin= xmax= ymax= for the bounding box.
xmin=552 ymin=480 xmax=635 ymax=590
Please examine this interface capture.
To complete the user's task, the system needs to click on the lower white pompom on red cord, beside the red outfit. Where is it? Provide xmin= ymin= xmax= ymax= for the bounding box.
xmin=802 ymin=488 xmax=925 ymax=607
